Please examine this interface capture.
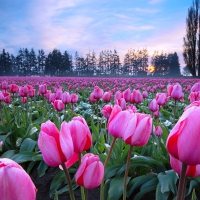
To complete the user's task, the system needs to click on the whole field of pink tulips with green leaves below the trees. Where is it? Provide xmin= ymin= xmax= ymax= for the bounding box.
xmin=0 ymin=77 xmax=200 ymax=200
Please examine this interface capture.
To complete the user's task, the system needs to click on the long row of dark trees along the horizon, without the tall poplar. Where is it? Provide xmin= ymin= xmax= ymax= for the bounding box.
xmin=0 ymin=48 xmax=180 ymax=76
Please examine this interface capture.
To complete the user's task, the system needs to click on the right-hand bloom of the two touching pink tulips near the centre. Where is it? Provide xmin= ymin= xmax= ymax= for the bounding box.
xmin=122 ymin=113 xmax=152 ymax=146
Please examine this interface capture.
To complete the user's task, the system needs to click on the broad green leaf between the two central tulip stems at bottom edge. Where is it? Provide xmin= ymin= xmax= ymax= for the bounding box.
xmin=108 ymin=176 xmax=130 ymax=200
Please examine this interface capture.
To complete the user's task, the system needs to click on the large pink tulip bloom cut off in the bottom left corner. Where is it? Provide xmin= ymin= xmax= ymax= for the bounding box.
xmin=0 ymin=158 xmax=37 ymax=200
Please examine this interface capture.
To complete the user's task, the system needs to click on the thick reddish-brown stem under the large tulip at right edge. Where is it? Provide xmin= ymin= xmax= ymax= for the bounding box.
xmin=177 ymin=162 xmax=187 ymax=200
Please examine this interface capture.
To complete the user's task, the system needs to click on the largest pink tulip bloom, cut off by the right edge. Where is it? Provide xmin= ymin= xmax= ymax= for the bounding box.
xmin=166 ymin=106 xmax=200 ymax=165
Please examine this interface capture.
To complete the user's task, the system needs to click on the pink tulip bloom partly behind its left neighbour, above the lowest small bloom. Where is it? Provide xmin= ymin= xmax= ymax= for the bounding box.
xmin=68 ymin=117 xmax=92 ymax=153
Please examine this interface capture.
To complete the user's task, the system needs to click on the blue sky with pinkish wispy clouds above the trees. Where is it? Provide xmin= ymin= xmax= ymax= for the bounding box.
xmin=0 ymin=0 xmax=192 ymax=66
